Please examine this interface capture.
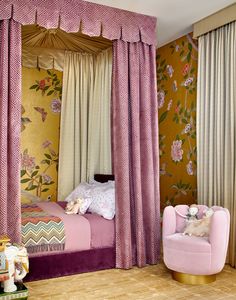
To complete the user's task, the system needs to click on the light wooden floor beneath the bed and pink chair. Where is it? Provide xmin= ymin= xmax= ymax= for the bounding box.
xmin=26 ymin=264 xmax=236 ymax=300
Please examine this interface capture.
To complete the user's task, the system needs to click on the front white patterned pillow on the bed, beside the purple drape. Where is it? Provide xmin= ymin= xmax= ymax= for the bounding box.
xmin=88 ymin=185 xmax=115 ymax=220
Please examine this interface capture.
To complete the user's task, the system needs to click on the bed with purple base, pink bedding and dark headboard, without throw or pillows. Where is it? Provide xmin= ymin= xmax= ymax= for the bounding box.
xmin=25 ymin=175 xmax=115 ymax=281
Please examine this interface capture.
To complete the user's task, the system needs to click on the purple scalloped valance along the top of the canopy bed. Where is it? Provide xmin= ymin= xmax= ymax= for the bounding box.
xmin=0 ymin=0 xmax=156 ymax=45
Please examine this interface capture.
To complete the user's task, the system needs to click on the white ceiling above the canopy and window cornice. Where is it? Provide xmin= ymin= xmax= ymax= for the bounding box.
xmin=85 ymin=0 xmax=235 ymax=47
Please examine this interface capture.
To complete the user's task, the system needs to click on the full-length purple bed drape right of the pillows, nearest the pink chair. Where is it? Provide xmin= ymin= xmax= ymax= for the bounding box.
xmin=112 ymin=40 xmax=160 ymax=268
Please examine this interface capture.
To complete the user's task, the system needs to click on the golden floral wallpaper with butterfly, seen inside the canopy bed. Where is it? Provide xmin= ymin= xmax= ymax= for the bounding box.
xmin=21 ymin=67 xmax=62 ymax=201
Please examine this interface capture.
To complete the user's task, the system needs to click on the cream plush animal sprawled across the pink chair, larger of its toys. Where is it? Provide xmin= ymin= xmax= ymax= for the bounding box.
xmin=183 ymin=208 xmax=214 ymax=237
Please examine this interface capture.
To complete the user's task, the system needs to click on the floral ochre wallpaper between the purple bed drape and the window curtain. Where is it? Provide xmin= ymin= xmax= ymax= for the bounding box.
xmin=156 ymin=34 xmax=198 ymax=209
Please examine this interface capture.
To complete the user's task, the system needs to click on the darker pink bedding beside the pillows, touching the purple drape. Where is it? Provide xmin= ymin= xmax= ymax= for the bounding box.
xmin=84 ymin=214 xmax=115 ymax=248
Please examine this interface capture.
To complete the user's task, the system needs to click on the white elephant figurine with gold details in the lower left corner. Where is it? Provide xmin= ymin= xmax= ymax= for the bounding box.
xmin=0 ymin=236 xmax=29 ymax=293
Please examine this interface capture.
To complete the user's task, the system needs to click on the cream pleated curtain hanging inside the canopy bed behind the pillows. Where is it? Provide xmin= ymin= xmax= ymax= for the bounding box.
xmin=58 ymin=49 xmax=112 ymax=200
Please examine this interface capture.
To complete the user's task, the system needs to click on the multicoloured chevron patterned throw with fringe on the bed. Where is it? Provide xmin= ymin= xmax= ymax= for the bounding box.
xmin=21 ymin=204 xmax=65 ymax=253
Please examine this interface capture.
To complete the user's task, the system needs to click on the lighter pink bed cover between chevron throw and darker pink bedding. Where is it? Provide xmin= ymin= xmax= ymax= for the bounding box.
xmin=38 ymin=202 xmax=91 ymax=251
